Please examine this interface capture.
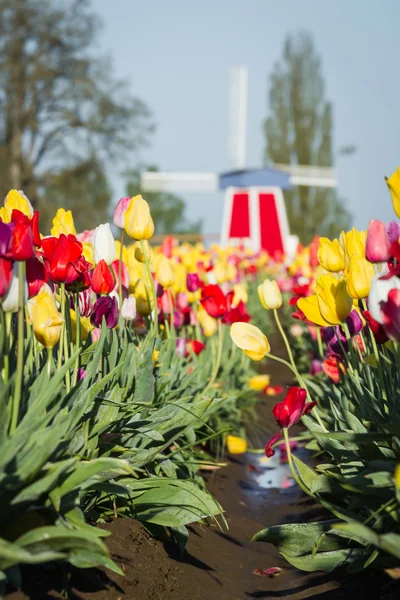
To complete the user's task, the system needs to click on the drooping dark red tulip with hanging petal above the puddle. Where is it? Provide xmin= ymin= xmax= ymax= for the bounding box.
xmin=265 ymin=386 xmax=317 ymax=457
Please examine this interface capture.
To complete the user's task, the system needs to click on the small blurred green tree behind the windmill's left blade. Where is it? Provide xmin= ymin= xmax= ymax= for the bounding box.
xmin=125 ymin=166 xmax=201 ymax=235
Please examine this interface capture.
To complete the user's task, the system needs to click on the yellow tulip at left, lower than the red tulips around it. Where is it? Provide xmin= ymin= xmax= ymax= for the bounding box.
xmin=28 ymin=283 xmax=64 ymax=348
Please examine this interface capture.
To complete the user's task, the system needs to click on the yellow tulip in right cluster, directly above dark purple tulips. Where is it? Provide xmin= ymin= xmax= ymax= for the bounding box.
xmin=317 ymin=274 xmax=353 ymax=325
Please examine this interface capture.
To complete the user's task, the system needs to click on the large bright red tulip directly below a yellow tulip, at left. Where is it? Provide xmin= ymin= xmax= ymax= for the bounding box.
xmin=42 ymin=233 xmax=91 ymax=289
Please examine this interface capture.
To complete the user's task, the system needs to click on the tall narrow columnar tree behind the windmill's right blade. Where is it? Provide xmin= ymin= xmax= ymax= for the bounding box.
xmin=264 ymin=33 xmax=351 ymax=243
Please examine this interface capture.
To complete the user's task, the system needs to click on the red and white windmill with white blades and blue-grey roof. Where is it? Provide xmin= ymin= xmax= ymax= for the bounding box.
xmin=141 ymin=66 xmax=336 ymax=255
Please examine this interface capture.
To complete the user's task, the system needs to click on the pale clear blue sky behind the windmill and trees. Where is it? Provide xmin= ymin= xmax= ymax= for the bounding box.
xmin=92 ymin=0 xmax=400 ymax=233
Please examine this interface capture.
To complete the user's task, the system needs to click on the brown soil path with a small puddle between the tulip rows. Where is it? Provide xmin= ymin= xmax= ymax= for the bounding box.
xmin=7 ymin=332 xmax=400 ymax=600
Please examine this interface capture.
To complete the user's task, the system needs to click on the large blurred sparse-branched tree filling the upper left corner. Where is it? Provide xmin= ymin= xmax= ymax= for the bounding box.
xmin=0 ymin=0 xmax=152 ymax=231
